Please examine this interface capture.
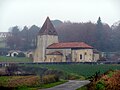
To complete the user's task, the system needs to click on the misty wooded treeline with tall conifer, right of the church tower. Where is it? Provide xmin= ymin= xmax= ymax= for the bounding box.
xmin=56 ymin=17 xmax=120 ymax=52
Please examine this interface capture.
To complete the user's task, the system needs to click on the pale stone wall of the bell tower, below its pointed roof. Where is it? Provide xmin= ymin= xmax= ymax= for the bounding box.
xmin=34 ymin=35 xmax=58 ymax=62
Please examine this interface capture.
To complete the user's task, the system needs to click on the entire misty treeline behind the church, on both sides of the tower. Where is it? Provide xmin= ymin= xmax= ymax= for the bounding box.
xmin=7 ymin=17 xmax=120 ymax=52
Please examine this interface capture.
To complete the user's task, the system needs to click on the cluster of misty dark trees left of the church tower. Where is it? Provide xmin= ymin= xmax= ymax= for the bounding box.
xmin=6 ymin=25 xmax=40 ymax=51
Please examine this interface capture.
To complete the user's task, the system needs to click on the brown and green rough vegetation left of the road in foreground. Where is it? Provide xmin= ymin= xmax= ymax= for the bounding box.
xmin=0 ymin=75 xmax=66 ymax=90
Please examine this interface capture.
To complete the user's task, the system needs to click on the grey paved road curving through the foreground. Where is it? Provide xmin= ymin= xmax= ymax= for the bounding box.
xmin=40 ymin=80 xmax=90 ymax=90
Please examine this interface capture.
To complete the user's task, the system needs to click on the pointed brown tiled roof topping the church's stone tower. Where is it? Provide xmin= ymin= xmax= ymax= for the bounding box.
xmin=39 ymin=17 xmax=58 ymax=35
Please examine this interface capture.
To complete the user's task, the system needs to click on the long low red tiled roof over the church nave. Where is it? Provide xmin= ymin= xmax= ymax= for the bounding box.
xmin=47 ymin=42 xmax=93 ymax=49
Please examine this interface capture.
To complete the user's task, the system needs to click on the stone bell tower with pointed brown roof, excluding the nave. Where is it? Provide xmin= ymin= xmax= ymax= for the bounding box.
xmin=34 ymin=17 xmax=58 ymax=62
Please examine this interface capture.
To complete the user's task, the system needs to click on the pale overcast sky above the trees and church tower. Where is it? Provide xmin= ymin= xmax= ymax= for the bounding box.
xmin=0 ymin=0 xmax=120 ymax=32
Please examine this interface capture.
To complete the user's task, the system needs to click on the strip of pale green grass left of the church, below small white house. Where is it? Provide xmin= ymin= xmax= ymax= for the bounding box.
xmin=0 ymin=56 xmax=32 ymax=62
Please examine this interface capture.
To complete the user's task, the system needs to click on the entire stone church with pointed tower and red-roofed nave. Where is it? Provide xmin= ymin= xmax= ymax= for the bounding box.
xmin=33 ymin=17 xmax=100 ymax=62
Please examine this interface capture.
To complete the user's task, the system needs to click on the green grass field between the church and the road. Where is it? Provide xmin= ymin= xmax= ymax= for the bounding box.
xmin=19 ymin=64 xmax=120 ymax=78
